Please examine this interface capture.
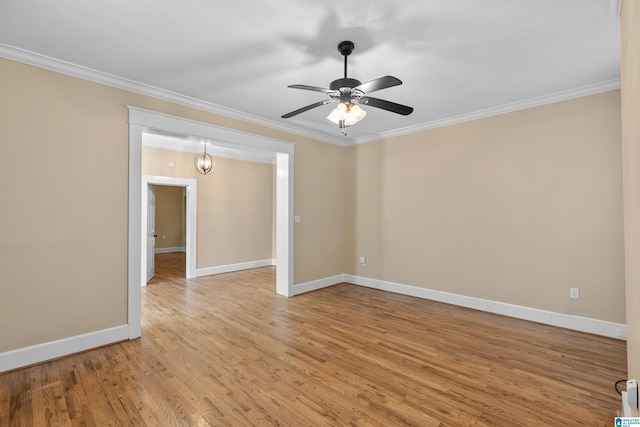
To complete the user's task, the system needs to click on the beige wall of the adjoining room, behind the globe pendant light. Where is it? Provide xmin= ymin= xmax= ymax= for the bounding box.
xmin=142 ymin=147 xmax=275 ymax=268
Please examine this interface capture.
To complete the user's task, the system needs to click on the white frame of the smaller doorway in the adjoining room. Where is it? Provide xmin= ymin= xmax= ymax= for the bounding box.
xmin=140 ymin=175 xmax=198 ymax=287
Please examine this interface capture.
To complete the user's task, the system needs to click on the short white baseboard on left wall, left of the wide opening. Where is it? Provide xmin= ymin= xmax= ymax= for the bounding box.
xmin=0 ymin=325 xmax=129 ymax=372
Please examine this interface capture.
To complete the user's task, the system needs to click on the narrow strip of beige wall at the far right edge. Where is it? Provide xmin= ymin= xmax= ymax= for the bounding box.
xmin=621 ymin=0 xmax=640 ymax=394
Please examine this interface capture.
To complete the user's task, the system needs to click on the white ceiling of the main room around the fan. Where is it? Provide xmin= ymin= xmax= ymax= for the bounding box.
xmin=0 ymin=0 xmax=620 ymax=145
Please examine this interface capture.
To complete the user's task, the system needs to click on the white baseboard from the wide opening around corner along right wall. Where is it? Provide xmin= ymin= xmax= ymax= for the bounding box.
xmin=294 ymin=274 xmax=627 ymax=340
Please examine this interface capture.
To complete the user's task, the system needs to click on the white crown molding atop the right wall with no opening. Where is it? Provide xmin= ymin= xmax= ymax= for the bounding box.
xmin=349 ymin=79 xmax=620 ymax=145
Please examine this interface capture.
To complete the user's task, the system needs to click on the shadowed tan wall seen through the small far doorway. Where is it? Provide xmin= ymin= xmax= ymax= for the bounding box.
xmin=153 ymin=185 xmax=186 ymax=249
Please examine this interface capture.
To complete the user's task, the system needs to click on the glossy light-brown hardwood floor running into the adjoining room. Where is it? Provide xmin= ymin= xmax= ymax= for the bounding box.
xmin=0 ymin=254 xmax=626 ymax=426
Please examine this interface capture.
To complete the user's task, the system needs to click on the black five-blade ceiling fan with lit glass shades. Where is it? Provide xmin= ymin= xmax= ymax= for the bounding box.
xmin=282 ymin=41 xmax=413 ymax=135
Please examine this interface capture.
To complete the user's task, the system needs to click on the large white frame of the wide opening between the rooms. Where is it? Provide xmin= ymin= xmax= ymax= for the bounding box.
xmin=127 ymin=105 xmax=294 ymax=339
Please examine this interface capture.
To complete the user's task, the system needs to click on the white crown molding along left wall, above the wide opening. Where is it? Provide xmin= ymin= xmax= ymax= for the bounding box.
xmin=0 ymin=43 xmax=345 ymax=147
